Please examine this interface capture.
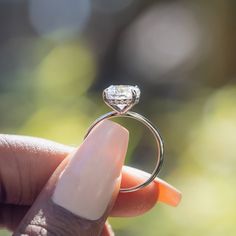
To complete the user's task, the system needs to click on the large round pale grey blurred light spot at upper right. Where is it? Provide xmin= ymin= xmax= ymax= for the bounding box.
xmin=121 ymin=3 xmax=200 ymax=81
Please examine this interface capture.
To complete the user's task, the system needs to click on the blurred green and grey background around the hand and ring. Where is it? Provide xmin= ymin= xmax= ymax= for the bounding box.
xmin=0 ymin=0 xmax=236 ymax=236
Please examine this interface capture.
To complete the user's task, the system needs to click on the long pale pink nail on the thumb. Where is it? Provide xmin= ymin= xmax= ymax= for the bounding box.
xmin=52 ymin=121 xmax=129 ymax=220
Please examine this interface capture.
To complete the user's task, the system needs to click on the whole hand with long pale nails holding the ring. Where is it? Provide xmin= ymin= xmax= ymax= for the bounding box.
xmin=0 ymin=121 xmax=181 ymax=236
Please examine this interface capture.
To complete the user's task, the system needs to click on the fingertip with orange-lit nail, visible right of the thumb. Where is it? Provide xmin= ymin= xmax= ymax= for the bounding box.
xmin=111 ymin=166 xmax=181 ymax=217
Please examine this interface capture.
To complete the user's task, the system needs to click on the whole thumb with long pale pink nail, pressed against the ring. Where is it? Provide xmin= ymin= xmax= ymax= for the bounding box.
xmin=13 ymin=121 xmax=128 ymax=236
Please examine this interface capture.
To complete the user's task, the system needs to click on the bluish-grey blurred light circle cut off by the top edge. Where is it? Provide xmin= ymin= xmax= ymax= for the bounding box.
xmin=29 ymin=0 xmax=91 ymax=40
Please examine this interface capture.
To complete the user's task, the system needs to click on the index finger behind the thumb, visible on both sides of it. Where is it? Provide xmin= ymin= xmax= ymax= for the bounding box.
xmin=0 ymin=135 xmax=181 ymax=224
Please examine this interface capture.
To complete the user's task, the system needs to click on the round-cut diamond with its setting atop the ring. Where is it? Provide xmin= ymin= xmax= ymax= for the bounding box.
xmin=103 ymin=85 xmax=140 ymax=113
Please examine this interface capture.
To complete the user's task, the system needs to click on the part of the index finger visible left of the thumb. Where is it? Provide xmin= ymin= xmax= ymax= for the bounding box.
xmin=0 ymin=135 xmax=73 ymax=205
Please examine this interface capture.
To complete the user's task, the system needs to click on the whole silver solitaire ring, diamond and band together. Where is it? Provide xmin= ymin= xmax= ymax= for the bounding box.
xmin=85 ymin=85 xmax=164 ymax=193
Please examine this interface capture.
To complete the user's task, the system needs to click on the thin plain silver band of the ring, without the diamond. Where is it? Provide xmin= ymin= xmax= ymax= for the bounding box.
xmin=84 ymin=111 xmax=164 ymax=193
